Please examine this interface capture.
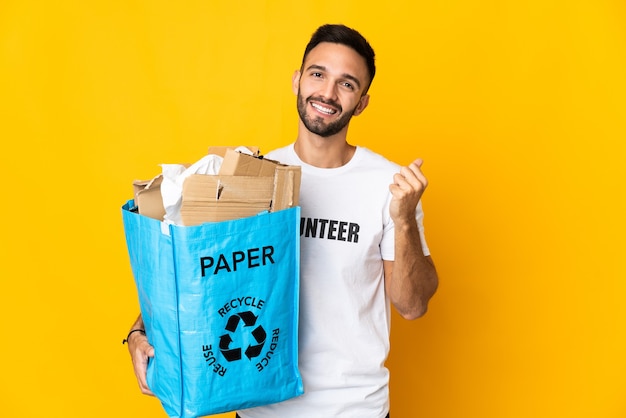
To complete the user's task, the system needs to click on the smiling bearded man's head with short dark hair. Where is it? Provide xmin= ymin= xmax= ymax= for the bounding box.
xmin=293 ymin=25 xmax=376 ymax=137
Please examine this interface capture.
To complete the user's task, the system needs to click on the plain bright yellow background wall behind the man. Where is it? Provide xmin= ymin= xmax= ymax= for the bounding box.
xmin=0 ymin=0 xmax=626 ymax=418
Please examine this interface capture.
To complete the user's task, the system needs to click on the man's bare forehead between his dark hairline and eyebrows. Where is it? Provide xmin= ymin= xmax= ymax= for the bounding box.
xmin=303 ymin=42 xmax=368 ymax=83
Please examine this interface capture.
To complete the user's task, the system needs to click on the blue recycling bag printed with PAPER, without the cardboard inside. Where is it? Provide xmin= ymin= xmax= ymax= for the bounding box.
xmin=122 ymin=200 xmax=303 ymax=418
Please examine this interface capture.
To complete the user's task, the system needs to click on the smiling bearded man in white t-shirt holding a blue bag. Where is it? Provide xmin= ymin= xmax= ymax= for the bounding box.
xmin=128 ymin=25 xmax=438 ymax=418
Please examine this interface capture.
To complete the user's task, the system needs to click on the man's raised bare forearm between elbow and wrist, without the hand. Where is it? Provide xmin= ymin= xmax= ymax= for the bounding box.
xmin=387 ymin=220 xmax=438 ymax=319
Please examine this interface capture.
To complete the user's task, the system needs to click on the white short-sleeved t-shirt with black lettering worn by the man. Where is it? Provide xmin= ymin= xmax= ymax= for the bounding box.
xmin=239 ymin=144 xmax=429 ymax=418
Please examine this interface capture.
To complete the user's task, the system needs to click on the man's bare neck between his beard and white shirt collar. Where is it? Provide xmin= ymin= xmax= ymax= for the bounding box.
xmin=294 ymin=127 xmax=356 ymax=168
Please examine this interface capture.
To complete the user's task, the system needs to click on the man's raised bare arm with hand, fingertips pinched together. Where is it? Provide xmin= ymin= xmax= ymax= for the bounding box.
xmin=383 ymin=159 xmax=438 ymax=319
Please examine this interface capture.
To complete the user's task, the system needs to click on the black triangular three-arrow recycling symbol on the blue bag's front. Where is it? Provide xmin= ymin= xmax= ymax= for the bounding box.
xmin=219 ymin=311 xmax=267 ymax=362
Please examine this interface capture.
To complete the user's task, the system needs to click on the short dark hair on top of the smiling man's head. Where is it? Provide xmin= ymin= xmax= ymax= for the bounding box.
xmin=302 ymin=25 xmax=376 ymax=91
